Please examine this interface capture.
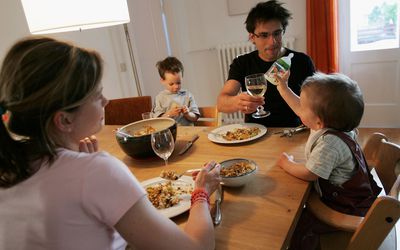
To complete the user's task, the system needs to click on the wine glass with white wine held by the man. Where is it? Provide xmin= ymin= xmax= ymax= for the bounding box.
xmin=244 ymin=73 xmax=271 ymax=118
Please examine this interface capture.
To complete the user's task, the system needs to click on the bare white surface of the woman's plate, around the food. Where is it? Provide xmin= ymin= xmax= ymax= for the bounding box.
xmin=141 ymin=176 xmax=194 ymax=218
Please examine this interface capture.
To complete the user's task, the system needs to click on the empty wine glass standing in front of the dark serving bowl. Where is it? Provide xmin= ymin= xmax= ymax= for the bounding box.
xmin=151 ymin=129 xmax=175 ymax=166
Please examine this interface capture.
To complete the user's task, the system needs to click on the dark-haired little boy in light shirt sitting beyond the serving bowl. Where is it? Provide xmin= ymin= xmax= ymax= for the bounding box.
xmin=153 ymin=57 xmax=200 ymax=126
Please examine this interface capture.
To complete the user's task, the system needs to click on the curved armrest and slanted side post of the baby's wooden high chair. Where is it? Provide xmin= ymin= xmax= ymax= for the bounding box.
xmin=307 ymin=176 xmax=400 ymax=250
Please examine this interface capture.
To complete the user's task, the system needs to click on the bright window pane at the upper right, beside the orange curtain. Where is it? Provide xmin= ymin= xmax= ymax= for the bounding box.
xmin=350 ymin=0 xmax=400 ymax=51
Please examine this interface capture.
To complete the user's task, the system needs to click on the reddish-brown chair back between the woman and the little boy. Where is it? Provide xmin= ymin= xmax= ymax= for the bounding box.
xmin=104 ymin=96 xmax=152 ymax=125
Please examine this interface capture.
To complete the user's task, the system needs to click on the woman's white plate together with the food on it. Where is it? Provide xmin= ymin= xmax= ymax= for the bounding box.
xmin=141 ymin=176 xmax=194 ymax=218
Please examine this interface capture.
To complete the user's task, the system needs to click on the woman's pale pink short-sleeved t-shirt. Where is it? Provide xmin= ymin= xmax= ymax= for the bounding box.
xmin=0 ymin=149 xmax=145 ymax=250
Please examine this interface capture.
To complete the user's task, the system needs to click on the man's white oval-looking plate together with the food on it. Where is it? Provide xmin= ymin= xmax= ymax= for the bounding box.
xmin=208 ymin=123 xmax=267 ymax=144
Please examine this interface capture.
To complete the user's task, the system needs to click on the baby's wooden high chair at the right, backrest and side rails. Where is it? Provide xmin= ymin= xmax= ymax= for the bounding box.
xmin=307 ymin=133 xmax=400 ymax=249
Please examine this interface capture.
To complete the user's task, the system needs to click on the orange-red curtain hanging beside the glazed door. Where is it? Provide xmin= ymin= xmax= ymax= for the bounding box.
xmin=307 ymin=0 xmax=339 ymax=73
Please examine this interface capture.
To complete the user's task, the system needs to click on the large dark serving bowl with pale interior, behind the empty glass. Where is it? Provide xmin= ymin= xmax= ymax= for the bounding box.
xmin=115 ymin=117 xmax=177 ymax=158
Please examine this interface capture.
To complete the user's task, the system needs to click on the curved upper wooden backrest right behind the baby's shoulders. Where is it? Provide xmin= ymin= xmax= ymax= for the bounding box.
xmin=363 ymin=133 xmax=400 ymax=194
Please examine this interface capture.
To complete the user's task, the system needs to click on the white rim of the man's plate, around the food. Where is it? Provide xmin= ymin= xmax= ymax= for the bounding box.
xmin=208 ymin=123 xmax=267 ymax=144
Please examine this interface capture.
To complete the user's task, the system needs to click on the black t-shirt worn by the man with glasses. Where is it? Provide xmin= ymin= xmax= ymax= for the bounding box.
xmin=228 ymin=49 xmax=315 ymax=127
